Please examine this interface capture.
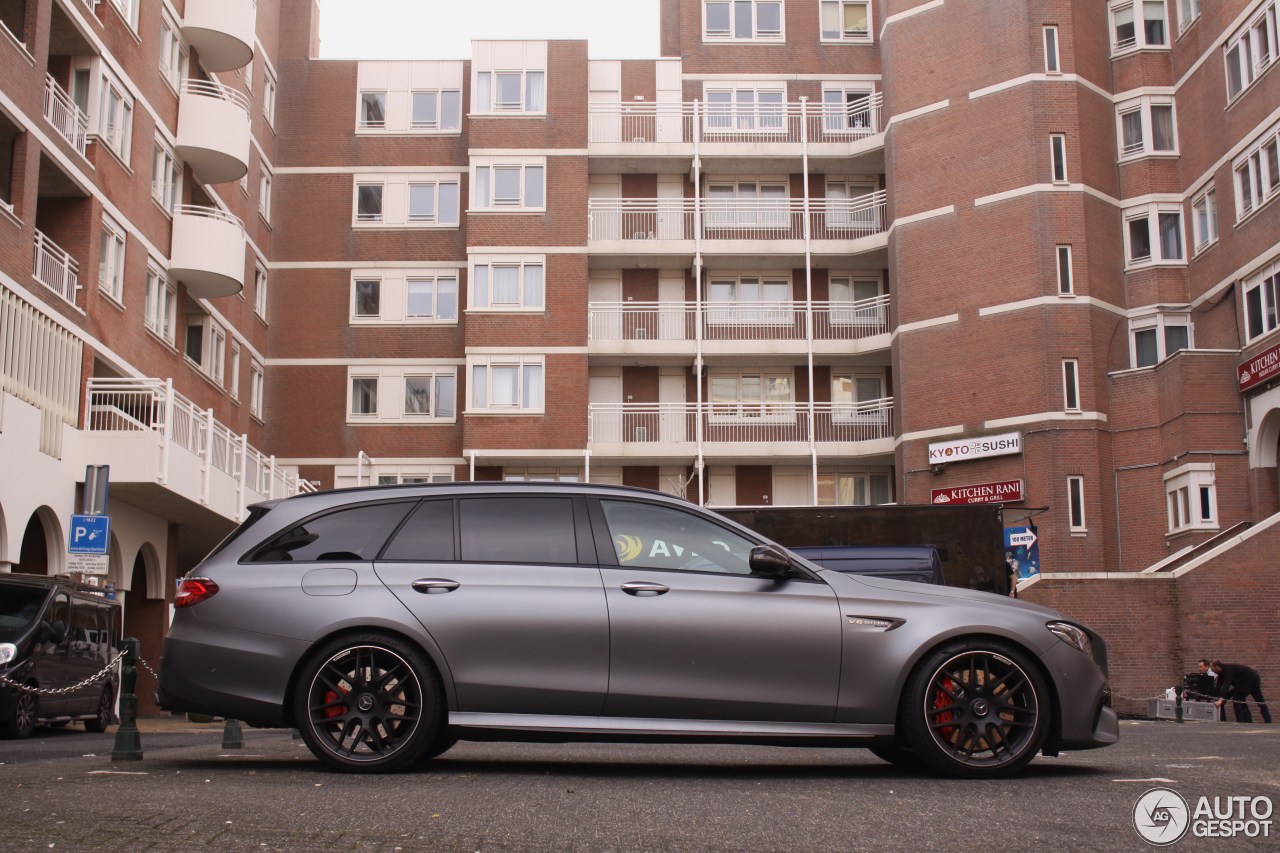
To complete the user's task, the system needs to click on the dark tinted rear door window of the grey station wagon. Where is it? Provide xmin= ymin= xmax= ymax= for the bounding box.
xmin=458 ymin=497 xmax=577 ymax=565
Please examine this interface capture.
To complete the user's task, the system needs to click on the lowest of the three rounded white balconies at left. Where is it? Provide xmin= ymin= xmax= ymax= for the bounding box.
xmin=169 ymin=205 xmax=246 ymax=300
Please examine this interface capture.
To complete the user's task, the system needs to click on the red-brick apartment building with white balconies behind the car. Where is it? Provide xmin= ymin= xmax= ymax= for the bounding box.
xmin=0 ymin=0 xmax=1280 ymax=711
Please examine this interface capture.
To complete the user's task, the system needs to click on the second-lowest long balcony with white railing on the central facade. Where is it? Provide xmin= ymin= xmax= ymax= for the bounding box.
xmin=588 ymin=295 xmax=890 ymax=355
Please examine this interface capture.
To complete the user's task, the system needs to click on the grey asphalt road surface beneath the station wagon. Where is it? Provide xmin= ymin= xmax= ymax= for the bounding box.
xmin=0 ymin=721 xmax=1280 ymax=853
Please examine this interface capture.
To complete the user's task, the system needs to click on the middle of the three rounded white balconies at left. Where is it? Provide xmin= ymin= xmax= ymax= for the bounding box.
xmin=177 ymin=79 xmax=250 ymax=183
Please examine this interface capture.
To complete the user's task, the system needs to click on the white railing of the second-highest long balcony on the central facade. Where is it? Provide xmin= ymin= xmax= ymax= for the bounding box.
xmin=586 ymin=190 xmax=886 ymax=241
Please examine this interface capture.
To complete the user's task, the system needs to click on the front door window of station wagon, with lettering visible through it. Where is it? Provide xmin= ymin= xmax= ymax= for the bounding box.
xmin=600 ymin=501 xmax=755 ymax=575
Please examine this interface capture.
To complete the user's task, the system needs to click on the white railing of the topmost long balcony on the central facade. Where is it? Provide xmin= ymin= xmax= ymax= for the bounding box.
xmin=588 ymin=92 xmax=883 ymax=145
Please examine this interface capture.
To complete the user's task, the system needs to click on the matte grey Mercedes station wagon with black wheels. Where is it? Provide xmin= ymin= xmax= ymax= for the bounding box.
xmin=156 ymin=483 xmax=1119 ymax=779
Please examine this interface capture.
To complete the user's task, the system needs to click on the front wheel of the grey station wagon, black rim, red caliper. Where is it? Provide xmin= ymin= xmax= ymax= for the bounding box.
xmin=900 ymin=640 xmax=1052 ymax=779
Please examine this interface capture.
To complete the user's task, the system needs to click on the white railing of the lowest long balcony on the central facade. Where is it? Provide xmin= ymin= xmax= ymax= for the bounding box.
xmin=588 ymin=397 xmax=893 ymax=444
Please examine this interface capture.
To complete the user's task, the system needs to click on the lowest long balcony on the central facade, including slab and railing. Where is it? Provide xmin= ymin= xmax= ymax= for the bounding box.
xmin=588 ymin=397 xmax=893 ymax=457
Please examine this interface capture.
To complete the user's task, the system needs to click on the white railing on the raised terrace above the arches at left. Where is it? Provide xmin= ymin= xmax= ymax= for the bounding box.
xmin=84 ymin=377 xmax=315 ymax=516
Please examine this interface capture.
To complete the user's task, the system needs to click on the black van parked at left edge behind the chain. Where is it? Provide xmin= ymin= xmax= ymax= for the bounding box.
xmin=0 ymin=574 xmax=120 ymax=738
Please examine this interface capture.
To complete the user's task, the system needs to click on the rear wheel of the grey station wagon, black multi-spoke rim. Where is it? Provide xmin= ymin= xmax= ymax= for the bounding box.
xmin=293 ymin=634 xmax=443 ymax=772
